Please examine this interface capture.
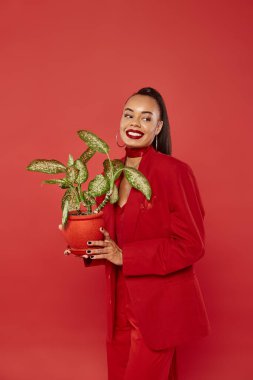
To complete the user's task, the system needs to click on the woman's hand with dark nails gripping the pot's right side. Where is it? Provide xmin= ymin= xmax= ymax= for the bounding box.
xmin=81 ymin=227 xmax=123 ymax=265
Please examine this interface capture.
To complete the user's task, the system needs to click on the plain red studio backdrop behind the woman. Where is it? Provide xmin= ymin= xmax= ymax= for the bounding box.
xmin=0 ymin=0 xmax=253 ymax=380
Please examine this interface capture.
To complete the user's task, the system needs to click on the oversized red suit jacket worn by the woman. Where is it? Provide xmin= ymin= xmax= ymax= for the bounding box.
xmin=84 ymin=146 xmax=211 ymax=350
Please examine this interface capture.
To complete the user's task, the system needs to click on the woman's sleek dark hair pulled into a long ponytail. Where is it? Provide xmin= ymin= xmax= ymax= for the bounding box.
xmin=126 ymin=87 xmax=172 ymax=155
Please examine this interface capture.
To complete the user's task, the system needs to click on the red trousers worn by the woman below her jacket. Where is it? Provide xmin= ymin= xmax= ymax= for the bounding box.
xmin=106 ymin=269 xmax=177 ymax=380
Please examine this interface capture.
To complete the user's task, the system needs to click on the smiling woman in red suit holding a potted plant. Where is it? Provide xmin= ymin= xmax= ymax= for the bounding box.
xmin=63 ymin=87 xmax=210 ymax=380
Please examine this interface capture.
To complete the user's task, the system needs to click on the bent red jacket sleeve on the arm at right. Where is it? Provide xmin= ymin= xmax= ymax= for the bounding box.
xmin=122 ymin=163 xmax=205 ymax=276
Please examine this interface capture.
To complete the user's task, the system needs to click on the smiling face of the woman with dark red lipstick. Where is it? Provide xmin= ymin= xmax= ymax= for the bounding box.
xmin=120 ymin=94 xmax=163 ymax=148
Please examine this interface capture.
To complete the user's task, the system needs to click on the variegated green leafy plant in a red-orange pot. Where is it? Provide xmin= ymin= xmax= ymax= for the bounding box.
xmin=26 ymin=130 xmax=151 ymax=255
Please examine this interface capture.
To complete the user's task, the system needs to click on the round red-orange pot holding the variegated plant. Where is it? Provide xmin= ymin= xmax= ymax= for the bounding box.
xmin=62 ymin=211 xmax=104 ymax=255
